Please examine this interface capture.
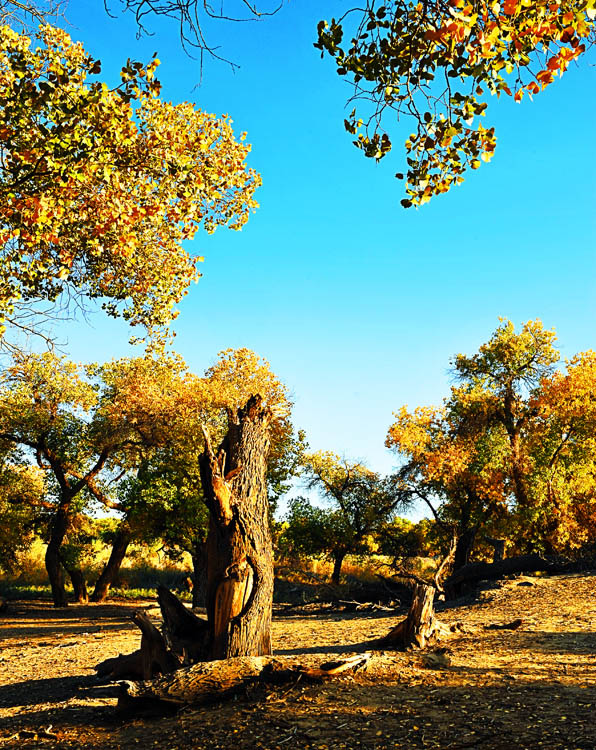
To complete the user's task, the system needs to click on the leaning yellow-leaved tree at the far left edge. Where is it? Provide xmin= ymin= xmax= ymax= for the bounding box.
xmin=0 ymin=352 xmax=191 ymax=606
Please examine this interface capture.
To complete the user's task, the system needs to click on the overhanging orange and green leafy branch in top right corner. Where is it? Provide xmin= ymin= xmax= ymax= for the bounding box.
xmin=315 ymin=0 xmax=596 ymax=208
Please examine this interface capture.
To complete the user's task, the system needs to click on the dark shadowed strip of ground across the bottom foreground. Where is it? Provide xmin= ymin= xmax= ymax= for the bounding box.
xmin=3 ymin=670 xmax=596 ymax=750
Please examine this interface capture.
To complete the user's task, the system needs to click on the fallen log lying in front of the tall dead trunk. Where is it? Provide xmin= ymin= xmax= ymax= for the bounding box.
xmin=118 ymin=653 xmax=370 ymax=711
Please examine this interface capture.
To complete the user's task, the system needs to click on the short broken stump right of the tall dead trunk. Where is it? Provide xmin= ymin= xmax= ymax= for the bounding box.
xmin=375 ymin=583 xmax=444 ymax=650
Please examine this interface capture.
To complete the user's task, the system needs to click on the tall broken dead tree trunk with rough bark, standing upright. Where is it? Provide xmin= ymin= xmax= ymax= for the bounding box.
xmin=200 ymin=396 xmax=273 ymax=659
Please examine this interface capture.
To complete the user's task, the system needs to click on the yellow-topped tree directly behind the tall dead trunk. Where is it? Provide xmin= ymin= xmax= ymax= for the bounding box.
xmin=93 ymin=349 xmax=304 ymax=604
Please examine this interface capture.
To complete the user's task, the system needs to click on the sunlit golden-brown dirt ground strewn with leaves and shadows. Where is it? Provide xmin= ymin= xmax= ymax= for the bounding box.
xmin=0 ymin=575 xmax=596 ymax=750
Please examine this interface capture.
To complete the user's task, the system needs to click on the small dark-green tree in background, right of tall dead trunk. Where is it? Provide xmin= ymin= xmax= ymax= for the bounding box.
xmin=284 ymin=451 xmax=403 ymax=585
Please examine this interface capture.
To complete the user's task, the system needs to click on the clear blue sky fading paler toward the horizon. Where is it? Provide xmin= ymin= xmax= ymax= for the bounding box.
xmin=53 ymin=0 xmax=596 ymax=516
